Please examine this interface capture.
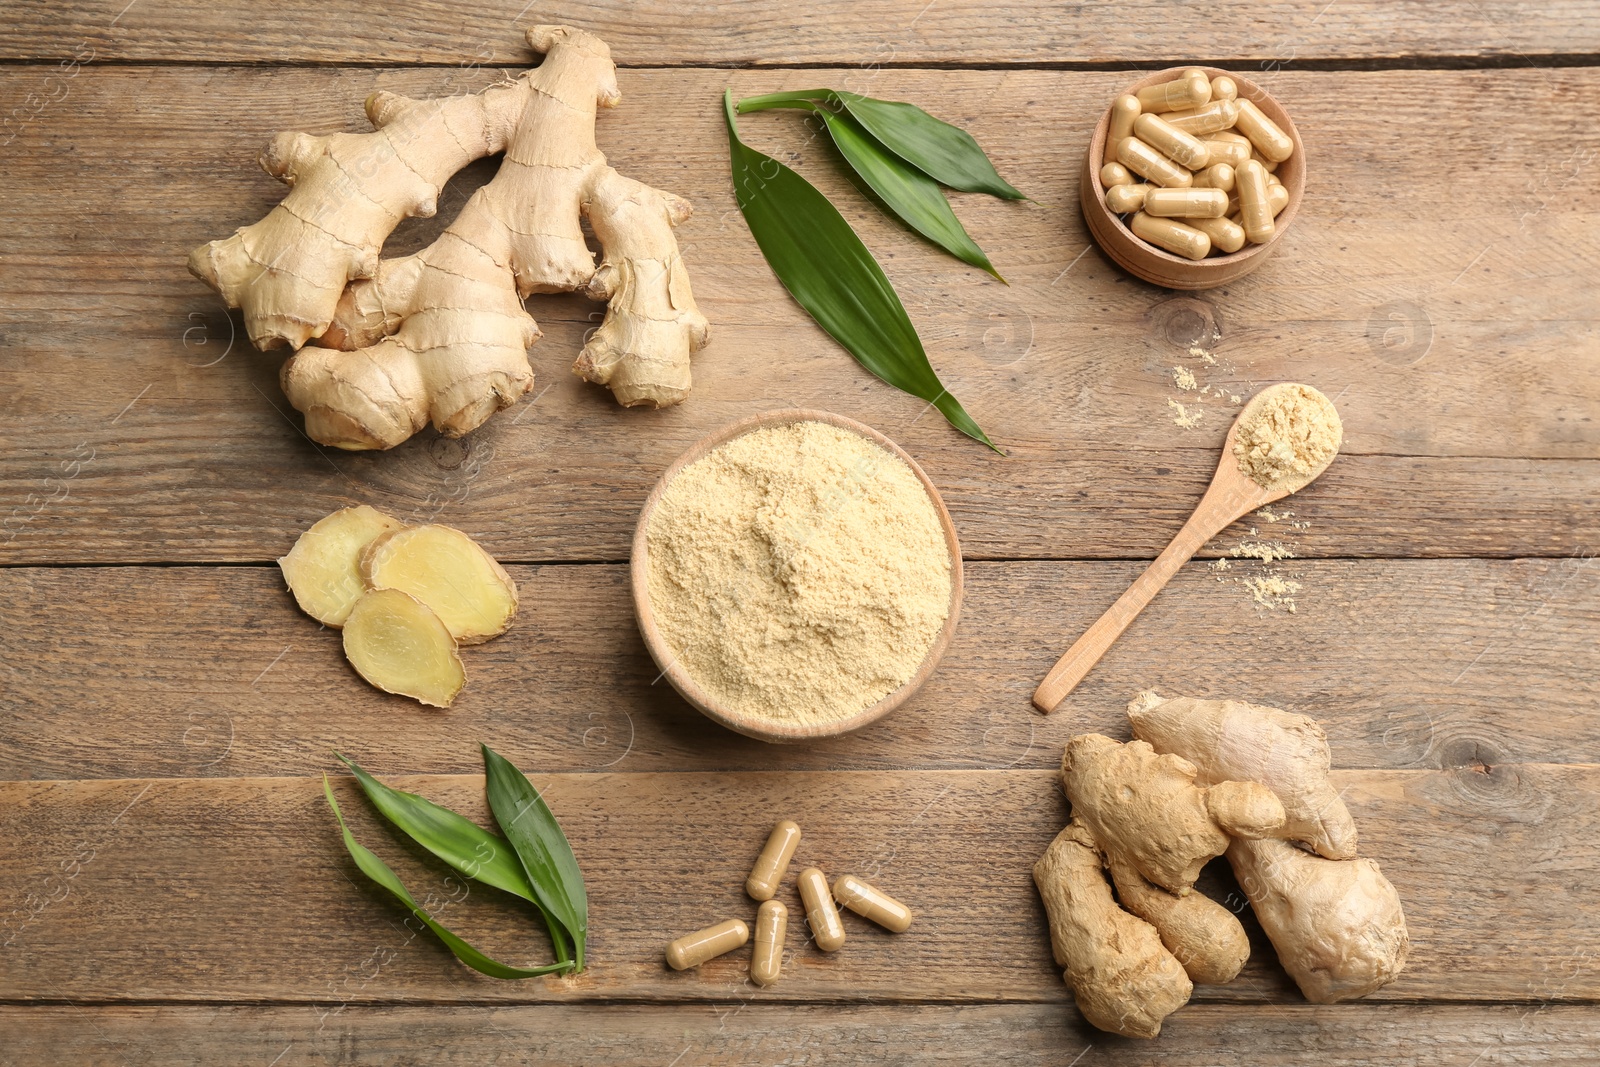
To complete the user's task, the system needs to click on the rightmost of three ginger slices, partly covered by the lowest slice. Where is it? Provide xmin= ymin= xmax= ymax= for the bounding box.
xmin=362 ymin=526 xmax=517 ymax=645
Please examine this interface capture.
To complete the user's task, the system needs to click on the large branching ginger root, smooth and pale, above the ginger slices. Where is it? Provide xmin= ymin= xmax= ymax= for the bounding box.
xmin=190 ymin=26 xmax=707 ymax=450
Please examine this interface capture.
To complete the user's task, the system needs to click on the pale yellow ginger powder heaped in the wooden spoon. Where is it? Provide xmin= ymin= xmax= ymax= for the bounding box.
xmin=1234 ymin=382 xmax=1342 ymax=493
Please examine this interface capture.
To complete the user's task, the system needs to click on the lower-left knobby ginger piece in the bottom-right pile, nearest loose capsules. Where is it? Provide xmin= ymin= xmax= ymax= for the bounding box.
xmin=1034 ymin=819 xmax=1194 ymax=1038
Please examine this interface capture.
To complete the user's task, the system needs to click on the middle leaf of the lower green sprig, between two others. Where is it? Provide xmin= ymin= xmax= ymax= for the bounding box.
xmin=333 ymin=752 xmax=573 ymax=963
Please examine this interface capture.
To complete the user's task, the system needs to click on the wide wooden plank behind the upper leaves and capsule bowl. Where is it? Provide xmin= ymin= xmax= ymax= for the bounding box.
xmin=0 ymin=66 xmax=1600 ymax=563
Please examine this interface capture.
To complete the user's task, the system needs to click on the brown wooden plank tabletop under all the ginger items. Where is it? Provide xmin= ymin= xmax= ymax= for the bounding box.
xmin=0 ymin=0 xmax=1600 ymax=1067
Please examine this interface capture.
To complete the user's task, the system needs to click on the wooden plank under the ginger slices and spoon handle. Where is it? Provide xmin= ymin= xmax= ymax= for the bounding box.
xmin=0 ymin=560 xmax=1600 ymax=779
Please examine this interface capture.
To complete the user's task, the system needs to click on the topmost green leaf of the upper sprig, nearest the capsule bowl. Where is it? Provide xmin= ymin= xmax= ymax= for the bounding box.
xmin=739 ymin=90 xmax=1027 ymax=200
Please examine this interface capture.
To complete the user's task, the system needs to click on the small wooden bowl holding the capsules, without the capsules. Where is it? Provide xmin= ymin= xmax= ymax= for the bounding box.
xmin=1078 ymin=67 xmax=1306 ymax=290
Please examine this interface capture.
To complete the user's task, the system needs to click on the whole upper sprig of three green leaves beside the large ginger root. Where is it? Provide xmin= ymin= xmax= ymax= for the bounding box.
xmin=723 ymin=90 xmax=1022 ymax=451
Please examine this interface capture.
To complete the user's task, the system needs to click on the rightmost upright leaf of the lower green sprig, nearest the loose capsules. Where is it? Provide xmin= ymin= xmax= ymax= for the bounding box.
xmin=483 ymin=745 xmax=589 ymax=971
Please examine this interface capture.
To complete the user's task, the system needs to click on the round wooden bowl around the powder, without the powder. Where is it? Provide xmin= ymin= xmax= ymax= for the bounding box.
xmin=629 ymin=408 xmax=962 ymax=742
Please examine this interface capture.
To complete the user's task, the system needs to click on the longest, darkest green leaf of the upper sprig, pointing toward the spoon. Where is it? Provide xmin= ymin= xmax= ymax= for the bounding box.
xmin=726 ymin=93 xmax=1000 ymax=454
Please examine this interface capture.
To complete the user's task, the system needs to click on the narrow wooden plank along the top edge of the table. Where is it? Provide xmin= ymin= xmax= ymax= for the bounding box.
xmin=0 ymin=0 xmax=1600 ymax=67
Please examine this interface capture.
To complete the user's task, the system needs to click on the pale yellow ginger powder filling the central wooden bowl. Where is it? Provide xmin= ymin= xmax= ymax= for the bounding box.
xmin=646 ymin=422 xmax=952 ymax=725
